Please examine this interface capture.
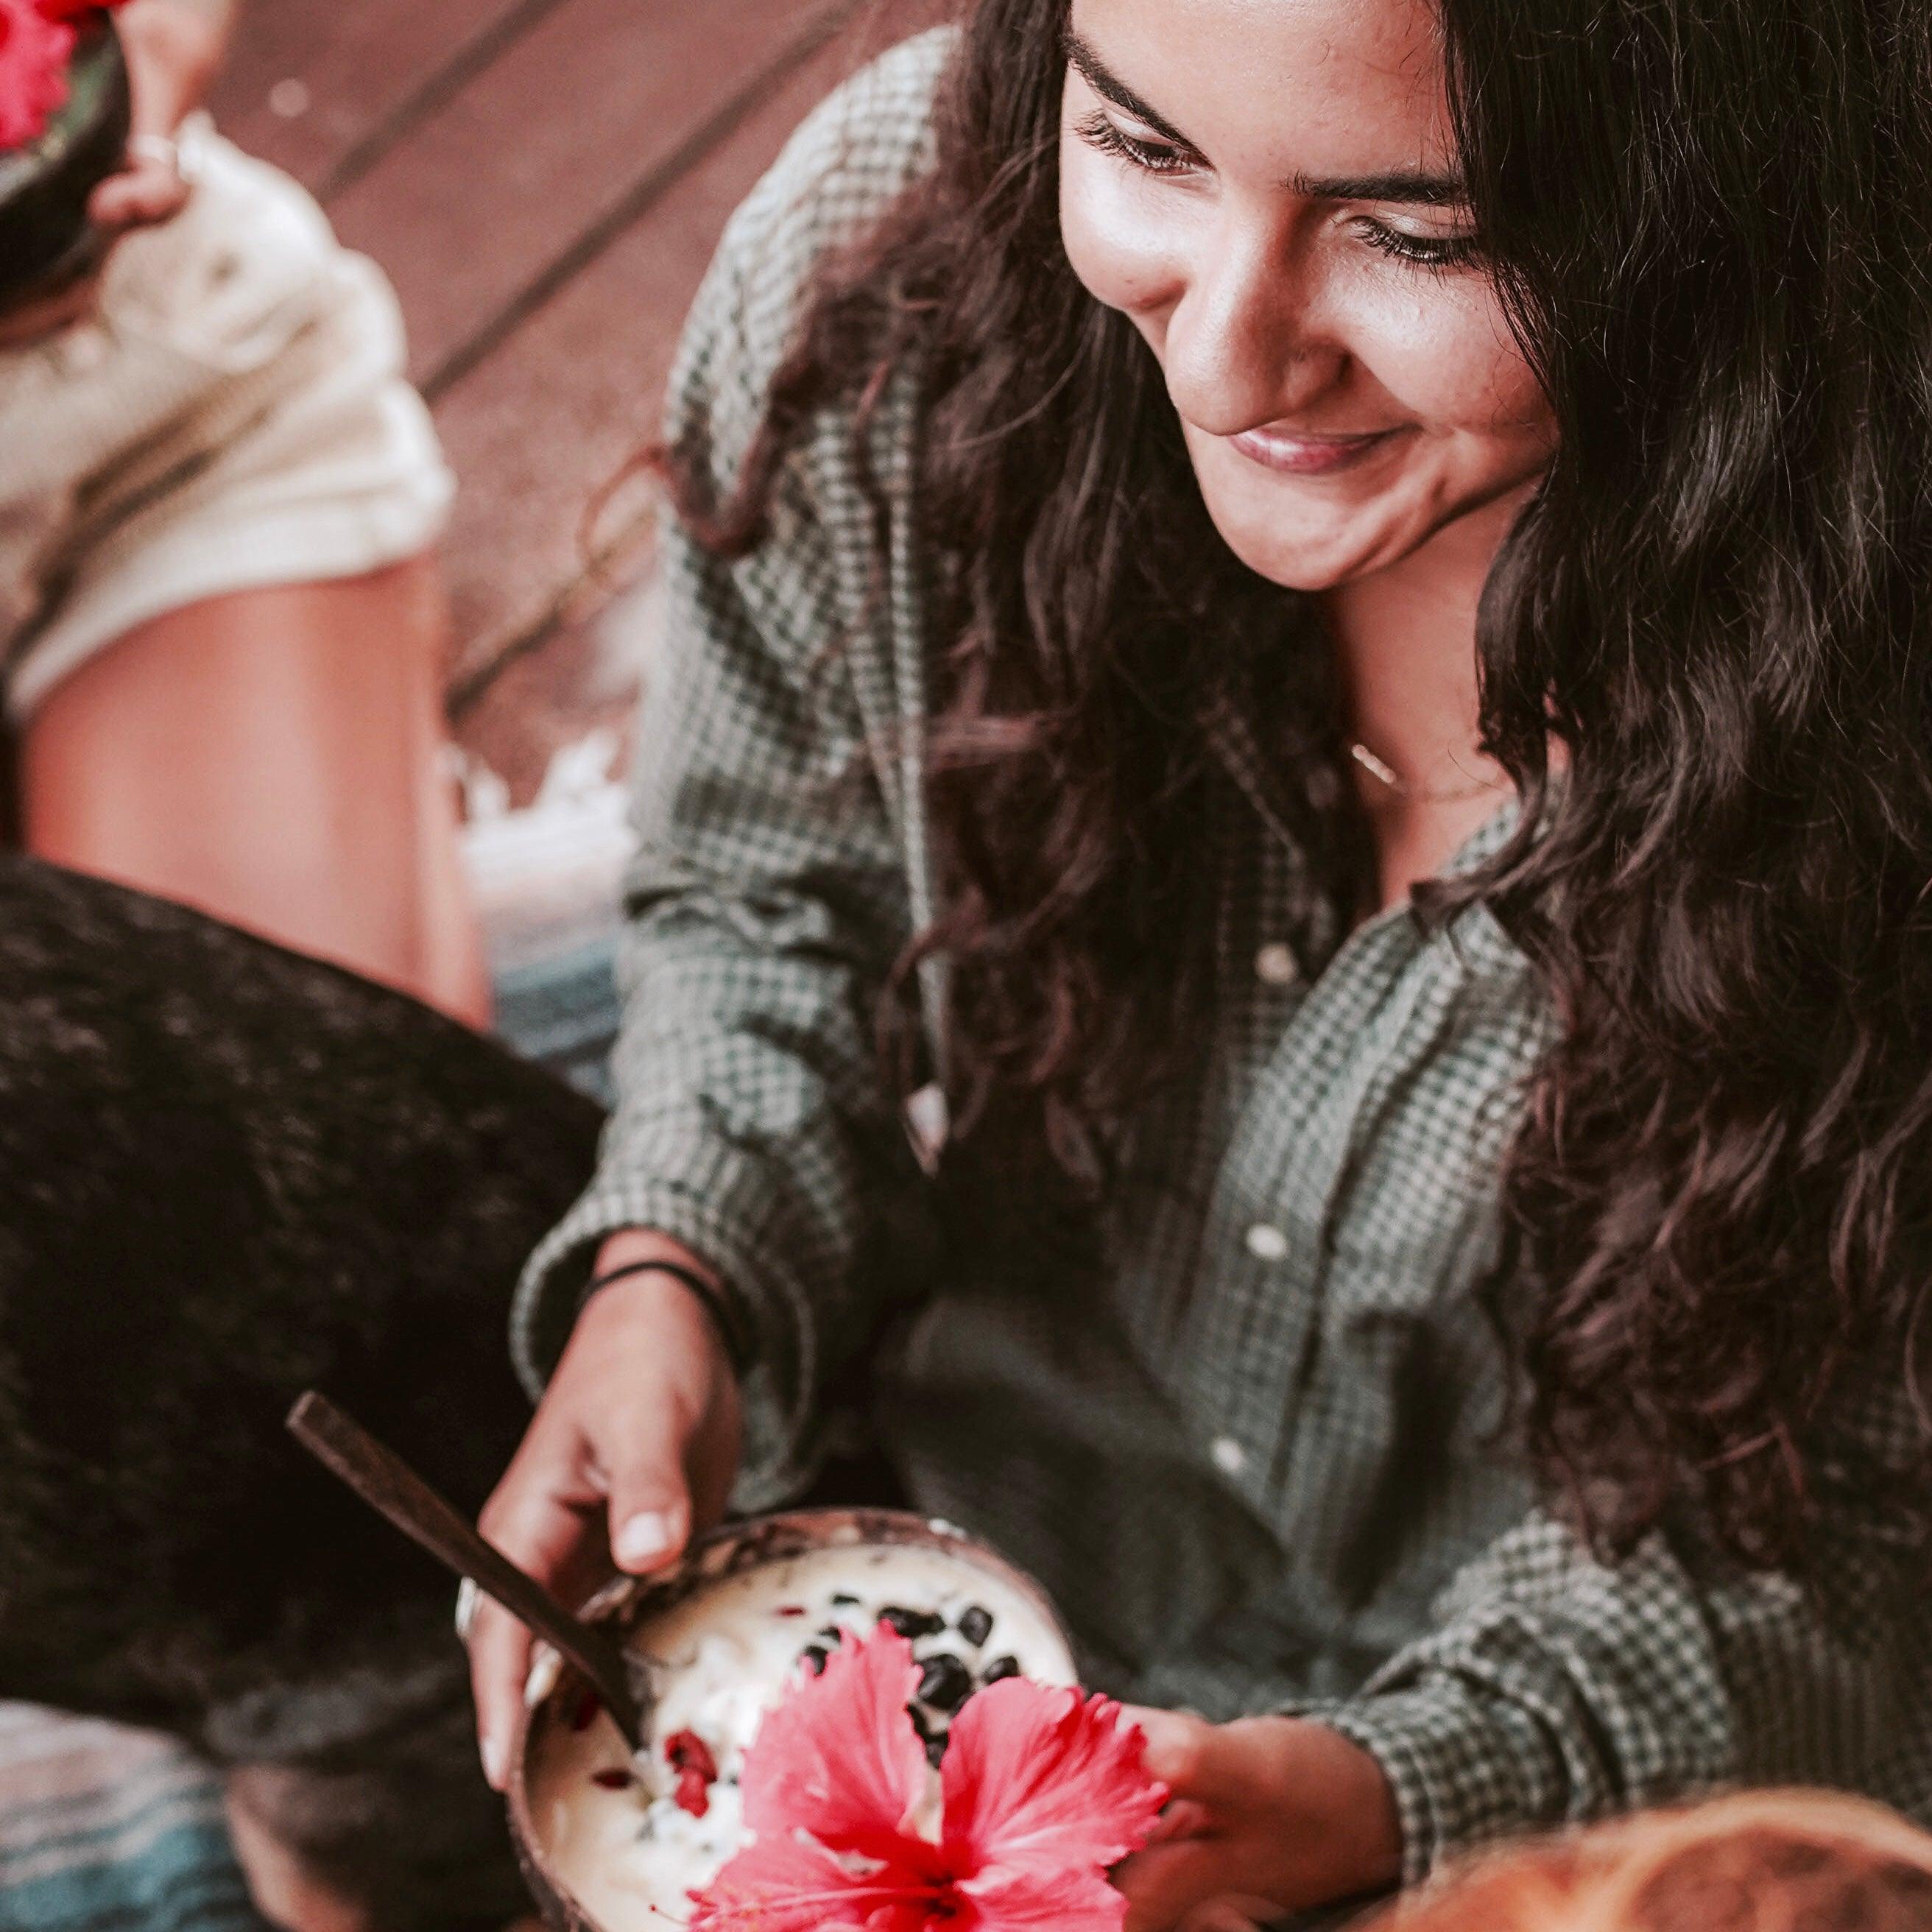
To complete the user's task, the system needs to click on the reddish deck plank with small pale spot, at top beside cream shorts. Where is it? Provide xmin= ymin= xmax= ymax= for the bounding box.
xmin=213 ymin=0 xmax=558 ymax=195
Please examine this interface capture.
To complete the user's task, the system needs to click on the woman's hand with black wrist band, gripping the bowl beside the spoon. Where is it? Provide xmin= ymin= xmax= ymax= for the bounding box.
xmin=470 ymin=1229 xmax=740 ymax=1791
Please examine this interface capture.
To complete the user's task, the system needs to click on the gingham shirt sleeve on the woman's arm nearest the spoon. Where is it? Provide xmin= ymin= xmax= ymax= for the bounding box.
xmin=512 ymin=41 xmax=942 ymax=1509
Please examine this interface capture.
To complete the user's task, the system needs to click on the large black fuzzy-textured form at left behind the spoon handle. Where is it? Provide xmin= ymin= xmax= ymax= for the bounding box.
xmin=0 ymin=860 xmax=601 ymax=1932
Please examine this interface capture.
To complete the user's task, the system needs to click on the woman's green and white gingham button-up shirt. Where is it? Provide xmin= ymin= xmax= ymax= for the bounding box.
xmin=516 ymin=33 xmax=1932 ymax=1878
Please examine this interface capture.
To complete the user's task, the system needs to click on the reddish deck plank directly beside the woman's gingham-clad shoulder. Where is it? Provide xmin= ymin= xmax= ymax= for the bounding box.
xmin=437 ymin=0 xmax=951 ymax=688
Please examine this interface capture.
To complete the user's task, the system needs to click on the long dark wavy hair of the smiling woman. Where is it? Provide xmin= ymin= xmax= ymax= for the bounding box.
xmin=672 ymin=0 xmax=1932 ymax=1565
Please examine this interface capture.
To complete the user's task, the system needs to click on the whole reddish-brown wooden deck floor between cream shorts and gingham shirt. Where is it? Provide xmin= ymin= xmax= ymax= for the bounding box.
xmin=214 ymin=0 xmax=943 ymax=796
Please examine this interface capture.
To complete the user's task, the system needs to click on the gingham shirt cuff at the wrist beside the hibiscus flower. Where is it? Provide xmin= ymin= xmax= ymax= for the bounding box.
xmin=1288 ymin=1677 xmax=1565 ymax=1886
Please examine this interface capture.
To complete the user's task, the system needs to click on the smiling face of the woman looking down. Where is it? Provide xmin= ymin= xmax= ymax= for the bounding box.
xmin=1061 ymin=0 xmax=1554 ymax=591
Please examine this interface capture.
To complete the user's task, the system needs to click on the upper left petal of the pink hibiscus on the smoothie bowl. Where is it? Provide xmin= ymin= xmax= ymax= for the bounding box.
xmin=742 ymin=1626 xmax=926 ymax=1858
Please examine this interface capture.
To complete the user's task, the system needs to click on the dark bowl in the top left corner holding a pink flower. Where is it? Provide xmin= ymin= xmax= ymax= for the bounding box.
xmin=0 ymin=15 xmax=130 ymax=307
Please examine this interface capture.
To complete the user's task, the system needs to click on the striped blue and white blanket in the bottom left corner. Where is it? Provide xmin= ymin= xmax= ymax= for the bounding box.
xmin=0 ymin=1704 xmax=263 ymax=1932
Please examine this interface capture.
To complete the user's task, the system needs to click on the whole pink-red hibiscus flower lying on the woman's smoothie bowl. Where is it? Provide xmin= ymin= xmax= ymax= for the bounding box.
xmin=691 ymin=1626 xmax=1167 ymax=1932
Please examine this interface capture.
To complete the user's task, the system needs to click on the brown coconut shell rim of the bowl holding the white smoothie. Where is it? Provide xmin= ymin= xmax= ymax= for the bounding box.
xmin=508 ymin=1509 xmax=1072 ymax=1932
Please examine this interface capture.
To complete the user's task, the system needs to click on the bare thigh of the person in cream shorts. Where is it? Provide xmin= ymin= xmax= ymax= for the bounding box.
xmin=21 ymin=557 xmax=489 ymax=1026
